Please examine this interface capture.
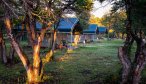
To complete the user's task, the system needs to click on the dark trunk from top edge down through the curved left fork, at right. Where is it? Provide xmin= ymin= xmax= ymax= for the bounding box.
xmin=118 ymin=0 xmax=133 ymax=84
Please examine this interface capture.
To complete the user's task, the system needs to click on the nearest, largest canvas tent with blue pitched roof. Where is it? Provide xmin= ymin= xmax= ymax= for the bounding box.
xmin=57 ymin=18 xmax=82 ymax=44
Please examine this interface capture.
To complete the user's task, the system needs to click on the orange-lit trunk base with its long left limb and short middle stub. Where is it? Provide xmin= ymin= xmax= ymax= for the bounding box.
xmin=4 ymin=17 xmax=39 ymax=84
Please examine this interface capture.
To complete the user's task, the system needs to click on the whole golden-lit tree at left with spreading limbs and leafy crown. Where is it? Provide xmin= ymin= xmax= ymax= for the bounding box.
xmin=0 ymin=0 xmax=93 ymax=83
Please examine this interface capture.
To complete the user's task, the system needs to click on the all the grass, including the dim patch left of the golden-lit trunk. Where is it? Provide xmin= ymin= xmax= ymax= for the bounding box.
xmin=0 ymin=40 xmax=123 ymax=84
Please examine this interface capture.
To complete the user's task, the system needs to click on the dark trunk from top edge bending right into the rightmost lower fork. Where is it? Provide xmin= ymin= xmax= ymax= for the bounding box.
xmin=125 ymin=0 xmax=146 ymax=84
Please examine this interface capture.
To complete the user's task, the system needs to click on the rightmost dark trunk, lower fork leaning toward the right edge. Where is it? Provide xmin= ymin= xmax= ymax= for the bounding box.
xmin=132 ymin=39 xmax=146 ymax=84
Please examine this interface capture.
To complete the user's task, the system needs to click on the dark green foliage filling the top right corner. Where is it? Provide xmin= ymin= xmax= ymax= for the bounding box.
xmin=131 ymin=0 xmax=146 ymax=36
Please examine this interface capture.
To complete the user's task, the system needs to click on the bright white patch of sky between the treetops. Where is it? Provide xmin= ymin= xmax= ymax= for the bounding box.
xmin=91 ymin=1 xmax=112 ymax=18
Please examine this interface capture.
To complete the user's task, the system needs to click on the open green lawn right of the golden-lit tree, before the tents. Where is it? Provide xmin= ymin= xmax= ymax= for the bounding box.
xmin=46 ymin=40 xmax=123 ymax=84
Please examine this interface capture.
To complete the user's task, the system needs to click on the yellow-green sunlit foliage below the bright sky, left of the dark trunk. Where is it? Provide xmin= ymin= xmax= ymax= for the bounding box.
xmin=102 ymin=10 xmax=126 ymax=33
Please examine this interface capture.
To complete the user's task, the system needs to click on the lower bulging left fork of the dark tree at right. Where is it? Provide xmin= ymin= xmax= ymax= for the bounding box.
xmin=118 ymin=36 xmax=134 ymax=84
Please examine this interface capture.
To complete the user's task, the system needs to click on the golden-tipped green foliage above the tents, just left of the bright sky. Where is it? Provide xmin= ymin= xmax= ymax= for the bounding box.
xmin=74 ymin=0 xmax=93 ymax=29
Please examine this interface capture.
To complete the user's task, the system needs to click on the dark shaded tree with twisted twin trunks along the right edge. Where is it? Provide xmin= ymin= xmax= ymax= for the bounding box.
xmin=113 ymin=0 xmax=146 ymax=84
